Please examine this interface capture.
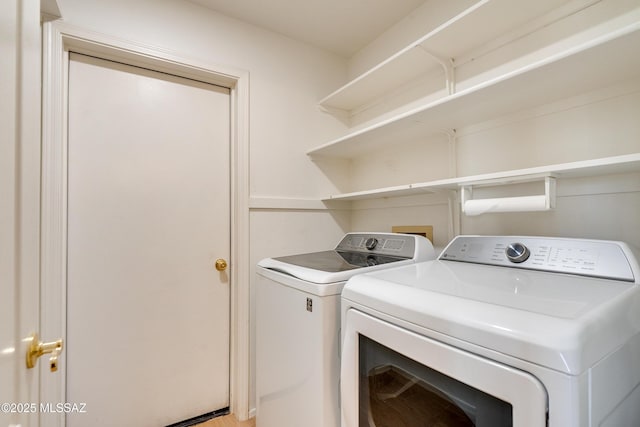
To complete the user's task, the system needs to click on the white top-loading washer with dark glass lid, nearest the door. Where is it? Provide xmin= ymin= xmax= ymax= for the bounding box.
xmin=256 ymin=233 xmax=435 ymax=427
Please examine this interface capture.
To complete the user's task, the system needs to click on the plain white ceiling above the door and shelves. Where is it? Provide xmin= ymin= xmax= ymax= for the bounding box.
xmin=191 ymin=0 xmax=425 ymax=57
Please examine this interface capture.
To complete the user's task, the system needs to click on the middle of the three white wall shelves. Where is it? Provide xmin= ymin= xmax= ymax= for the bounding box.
xmin=307 ymin=20 xmax=640 ymax=158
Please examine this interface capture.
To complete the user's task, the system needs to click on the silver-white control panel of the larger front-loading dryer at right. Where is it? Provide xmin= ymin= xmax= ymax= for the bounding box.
xmin=438 ymin=236 xmax=636 ymax=282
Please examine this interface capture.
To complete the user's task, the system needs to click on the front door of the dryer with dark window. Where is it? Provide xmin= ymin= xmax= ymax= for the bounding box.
xmin=341 ymin=309 xmax=547 ymax=427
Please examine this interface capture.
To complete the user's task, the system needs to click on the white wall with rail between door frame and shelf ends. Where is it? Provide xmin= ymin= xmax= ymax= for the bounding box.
xmin=54 ymin=0 xmax=350 ymax=416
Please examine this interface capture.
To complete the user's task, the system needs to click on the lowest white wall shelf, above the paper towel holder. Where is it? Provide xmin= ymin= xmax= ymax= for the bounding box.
xmin=324 ymin=153 xmax=640 ymax=201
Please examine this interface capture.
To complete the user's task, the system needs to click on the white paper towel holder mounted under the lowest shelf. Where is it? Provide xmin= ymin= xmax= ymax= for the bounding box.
xmin=460 ymin=176 xmax=556 ymax=216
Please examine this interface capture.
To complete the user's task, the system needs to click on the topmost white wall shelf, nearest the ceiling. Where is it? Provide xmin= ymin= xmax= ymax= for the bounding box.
xmin=320 ymin=0 xmax=566 ymax=111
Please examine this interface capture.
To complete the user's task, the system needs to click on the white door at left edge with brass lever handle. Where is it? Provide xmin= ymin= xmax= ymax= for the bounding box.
xmin=0 ymin=0 xmax=42 ymax=427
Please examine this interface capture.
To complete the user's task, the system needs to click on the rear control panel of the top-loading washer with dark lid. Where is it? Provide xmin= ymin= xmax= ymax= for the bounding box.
xmin=336 ymin=233 xmax=416 ymax=258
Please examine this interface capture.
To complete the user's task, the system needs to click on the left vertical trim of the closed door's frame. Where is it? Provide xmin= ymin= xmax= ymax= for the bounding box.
xmin=40 ymin=23 xmax=68 ymax=427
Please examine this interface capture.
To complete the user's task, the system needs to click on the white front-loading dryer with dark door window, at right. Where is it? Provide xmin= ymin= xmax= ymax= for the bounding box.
xmin=341 ymin=236 xmax=640 ymax=427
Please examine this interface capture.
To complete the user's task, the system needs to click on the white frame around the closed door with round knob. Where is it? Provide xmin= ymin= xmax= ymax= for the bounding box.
xmin=40 ymin=21 xmax=250 ymax=426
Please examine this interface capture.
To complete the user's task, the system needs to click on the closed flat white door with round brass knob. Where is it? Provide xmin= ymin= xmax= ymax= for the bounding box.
xmin=66 ymin=54 xmax=230 ymax=427
